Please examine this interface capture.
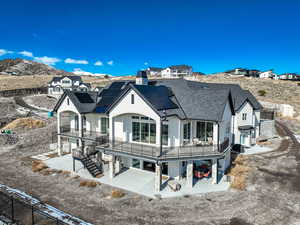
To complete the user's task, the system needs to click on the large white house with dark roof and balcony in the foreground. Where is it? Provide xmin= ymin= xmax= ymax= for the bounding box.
xmin=53 ymin=71 xmax=260 ymax=192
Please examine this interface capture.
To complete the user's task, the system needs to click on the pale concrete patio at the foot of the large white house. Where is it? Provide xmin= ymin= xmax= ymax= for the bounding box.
xmin=44 ymin=154 xmax=230 ymax=198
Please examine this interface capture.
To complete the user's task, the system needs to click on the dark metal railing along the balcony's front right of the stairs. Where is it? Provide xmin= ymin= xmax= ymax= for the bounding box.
xmin=96 ymin=139 xmax=229 ymax=160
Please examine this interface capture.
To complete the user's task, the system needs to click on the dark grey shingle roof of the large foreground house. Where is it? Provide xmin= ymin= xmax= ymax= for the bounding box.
xmin=52 ymin=79 xmax=261 ymax=121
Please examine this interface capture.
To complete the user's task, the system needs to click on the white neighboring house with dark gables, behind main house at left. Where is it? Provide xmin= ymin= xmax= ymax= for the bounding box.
xmin=48 ymin=76 xmax=91 ymax=97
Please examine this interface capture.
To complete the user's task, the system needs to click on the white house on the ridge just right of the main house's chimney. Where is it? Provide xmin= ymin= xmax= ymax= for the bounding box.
xmin=161 ymin=65 xmax=193 ymax=78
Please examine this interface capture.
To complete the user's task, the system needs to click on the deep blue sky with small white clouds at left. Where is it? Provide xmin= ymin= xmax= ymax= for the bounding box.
xmin=0 ymin=0 xmax=300 ymax=75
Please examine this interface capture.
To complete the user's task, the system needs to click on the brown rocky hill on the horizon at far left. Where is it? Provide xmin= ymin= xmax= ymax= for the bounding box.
xmin=0 ymin=58 xmax=74 ymax=76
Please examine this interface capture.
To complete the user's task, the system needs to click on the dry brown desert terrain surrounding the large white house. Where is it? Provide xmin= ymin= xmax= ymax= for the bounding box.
xmin=0 ymin=75 xmax=300 ymax=225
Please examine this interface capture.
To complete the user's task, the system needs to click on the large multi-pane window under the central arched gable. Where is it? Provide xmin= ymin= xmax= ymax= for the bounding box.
xmin=132 ymin=116 xmax=156 ymax=144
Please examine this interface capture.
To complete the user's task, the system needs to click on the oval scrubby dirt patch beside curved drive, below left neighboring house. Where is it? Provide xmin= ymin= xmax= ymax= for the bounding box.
xmin=23 ymin=94 xmax=57 ymax=111
